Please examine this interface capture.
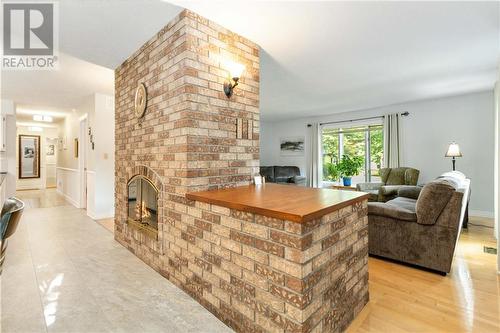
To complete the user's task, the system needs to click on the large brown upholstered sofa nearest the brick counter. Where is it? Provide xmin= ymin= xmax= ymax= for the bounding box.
xmin=368 ymin=173 xmax=470 ymax=274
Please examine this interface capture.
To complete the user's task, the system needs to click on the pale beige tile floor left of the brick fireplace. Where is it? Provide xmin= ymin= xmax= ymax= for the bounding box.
xmin=1 ymin=189 xmax=231 ymax=333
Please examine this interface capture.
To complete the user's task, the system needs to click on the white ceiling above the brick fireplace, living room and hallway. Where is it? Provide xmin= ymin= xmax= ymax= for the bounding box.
xmin=2 ymin=0 xmax=500 ymax=120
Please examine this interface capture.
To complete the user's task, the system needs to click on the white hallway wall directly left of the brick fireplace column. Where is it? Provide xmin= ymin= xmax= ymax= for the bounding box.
xmin=57 ymin=94 xmax=115 ymax=219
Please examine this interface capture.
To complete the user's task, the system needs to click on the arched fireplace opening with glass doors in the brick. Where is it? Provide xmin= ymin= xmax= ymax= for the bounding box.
xmin=128 ymin=175 xmax=158 ymax=230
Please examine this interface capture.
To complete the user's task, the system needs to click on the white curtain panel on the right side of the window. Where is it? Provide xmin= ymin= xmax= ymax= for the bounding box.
xmin=384 ymin=113 xmax=403 ymax=168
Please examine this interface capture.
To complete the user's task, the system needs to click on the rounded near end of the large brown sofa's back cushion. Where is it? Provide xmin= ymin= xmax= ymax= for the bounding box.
xmin=416 ymin=179 xmax=455 ymax=225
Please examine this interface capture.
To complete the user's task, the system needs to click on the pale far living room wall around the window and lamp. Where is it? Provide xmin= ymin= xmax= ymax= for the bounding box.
xmin=260 ymin=91 xmax=494 ymax=217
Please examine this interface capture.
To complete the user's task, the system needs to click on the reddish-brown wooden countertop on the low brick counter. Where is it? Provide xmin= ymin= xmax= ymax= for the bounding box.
xmin=186 ymin=183 xmax=368 ymax=222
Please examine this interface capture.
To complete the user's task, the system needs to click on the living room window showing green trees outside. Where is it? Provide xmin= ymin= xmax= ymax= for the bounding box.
xmin=321 ymin=124 xmax=384 ymax=184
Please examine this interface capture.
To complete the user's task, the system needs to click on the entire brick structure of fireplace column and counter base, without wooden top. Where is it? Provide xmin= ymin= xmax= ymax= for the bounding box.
xmin=115 ymin=10 xmax=368 ymax=332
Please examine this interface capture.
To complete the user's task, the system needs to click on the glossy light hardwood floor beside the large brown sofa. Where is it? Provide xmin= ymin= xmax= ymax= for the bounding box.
xmin=348 ymin=218 xmax=500 ymax=333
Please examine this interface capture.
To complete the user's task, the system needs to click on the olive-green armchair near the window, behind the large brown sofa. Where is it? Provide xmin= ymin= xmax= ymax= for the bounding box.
xmin=356 ymin=167 xmax=420 ymax=202
